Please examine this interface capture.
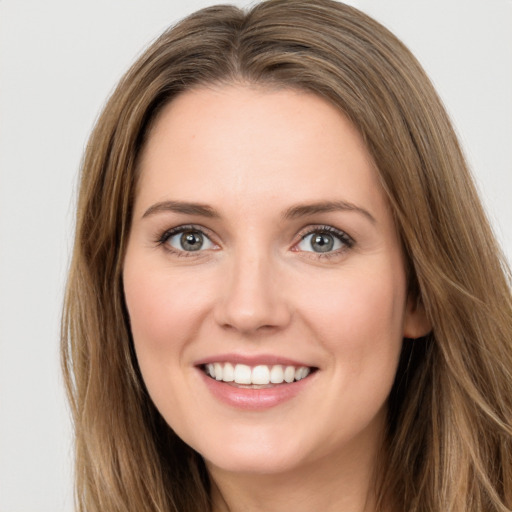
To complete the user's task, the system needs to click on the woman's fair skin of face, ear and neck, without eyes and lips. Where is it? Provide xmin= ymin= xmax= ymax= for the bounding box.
xmin=123 ymin=85 xmax=428 ymax=512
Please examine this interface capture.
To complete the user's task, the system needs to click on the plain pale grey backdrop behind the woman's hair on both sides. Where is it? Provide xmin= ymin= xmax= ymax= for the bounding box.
xmin=0 ymin=0 xmax=512 ymax=512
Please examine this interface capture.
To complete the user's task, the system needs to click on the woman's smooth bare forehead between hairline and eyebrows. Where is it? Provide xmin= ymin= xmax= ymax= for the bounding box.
xmin=137 ymin=85 xmax=383 ymax=218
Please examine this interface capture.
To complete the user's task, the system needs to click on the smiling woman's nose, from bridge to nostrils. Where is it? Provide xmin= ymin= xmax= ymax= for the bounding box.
xmin=215 ymin=249 xmax=292 ymax=335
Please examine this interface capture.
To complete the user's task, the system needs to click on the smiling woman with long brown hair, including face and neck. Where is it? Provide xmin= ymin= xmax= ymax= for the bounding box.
xmin=63 ymin=0 xmax=512 ymax=512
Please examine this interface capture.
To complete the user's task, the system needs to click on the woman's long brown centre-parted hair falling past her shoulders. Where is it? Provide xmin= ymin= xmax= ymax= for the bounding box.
xmin=62 ymin=0 xmax=512 ymax=512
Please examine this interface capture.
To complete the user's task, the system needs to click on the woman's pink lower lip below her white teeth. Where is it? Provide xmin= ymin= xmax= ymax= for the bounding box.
xmin=198 ymin=369 xmax=314 ymax=411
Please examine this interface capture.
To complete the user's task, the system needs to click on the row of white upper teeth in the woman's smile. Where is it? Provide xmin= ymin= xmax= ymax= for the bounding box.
xmin=205 ymin=363 xmax=311 ymax=385
